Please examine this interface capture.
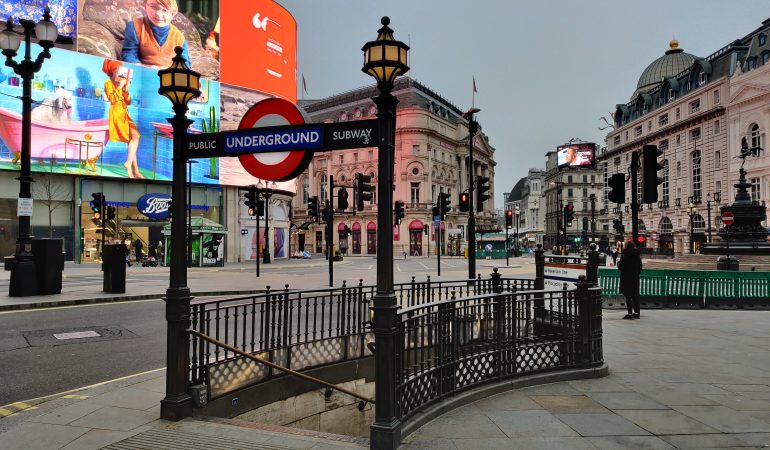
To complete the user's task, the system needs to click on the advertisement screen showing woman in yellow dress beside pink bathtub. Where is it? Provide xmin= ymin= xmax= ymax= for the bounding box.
xmin=0 ymin=45 xmax=220 ymax=184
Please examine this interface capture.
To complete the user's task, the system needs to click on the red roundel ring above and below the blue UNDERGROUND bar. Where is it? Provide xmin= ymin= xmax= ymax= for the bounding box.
xmin=238 ymin=98 xmax=313 ymax=181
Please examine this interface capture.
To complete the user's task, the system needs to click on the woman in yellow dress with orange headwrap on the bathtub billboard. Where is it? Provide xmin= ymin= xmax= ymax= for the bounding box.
xmin=102 ymin=59 xmax=144 ymax=178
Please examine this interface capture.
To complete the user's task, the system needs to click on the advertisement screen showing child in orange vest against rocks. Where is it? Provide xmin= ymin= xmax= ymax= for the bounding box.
xmin=77 ymin=0 xmax=219 ymax=80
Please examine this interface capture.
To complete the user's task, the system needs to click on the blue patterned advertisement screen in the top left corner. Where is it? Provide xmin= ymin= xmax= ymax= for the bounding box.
xmin=0 ymin=0 xmax=78 ymax=39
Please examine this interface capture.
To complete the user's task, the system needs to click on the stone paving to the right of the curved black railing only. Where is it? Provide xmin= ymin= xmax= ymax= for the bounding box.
xmin=403 ymin=310 xmax=770 ymax=450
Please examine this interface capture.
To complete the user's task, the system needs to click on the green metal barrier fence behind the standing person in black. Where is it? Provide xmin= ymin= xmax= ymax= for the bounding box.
xmin=599 ymin=267 xmax=770 ymax=309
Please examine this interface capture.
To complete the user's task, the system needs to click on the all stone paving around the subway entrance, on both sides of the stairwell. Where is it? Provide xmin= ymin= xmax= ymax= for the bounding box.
xmin=0 ymin=310 xmax=770 ymax=450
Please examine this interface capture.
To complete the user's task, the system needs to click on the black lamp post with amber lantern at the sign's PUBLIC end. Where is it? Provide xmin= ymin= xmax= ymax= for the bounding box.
xmin=158 ymin=47 xmax=200 ymax=420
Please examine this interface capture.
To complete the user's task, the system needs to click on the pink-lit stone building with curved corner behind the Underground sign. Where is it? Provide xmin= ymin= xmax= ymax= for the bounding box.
xmin=295 ymin=77 xmax=497 ymax=255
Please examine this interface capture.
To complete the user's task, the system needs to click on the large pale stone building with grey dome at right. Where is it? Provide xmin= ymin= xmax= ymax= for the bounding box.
xmin=597 ymin=19 xmax=770 ymax=256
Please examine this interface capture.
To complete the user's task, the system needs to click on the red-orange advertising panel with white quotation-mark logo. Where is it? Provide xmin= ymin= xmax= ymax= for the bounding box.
xmin=219 ymin=0 xmax=297 ymax=103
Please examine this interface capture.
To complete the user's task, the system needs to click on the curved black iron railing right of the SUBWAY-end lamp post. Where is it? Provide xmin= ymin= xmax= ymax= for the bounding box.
xmin=396 ymin=282 xmax=603 ymax=420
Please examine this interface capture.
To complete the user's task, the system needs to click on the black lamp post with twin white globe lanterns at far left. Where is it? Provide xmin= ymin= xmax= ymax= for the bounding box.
xmin=0 ymin=7 xmax=59 ymax=297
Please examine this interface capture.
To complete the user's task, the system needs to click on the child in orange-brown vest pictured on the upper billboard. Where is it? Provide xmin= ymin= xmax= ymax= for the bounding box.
xmin=121 ymin=0 xmax=190 ymax=69
